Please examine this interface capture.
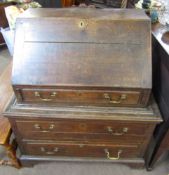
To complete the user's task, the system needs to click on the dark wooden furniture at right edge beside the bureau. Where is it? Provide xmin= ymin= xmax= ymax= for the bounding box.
xmin=146 ymin=23 xmax=169 ymax=170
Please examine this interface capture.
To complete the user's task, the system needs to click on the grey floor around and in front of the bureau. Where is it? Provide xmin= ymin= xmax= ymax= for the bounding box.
xmin=0 ymin=49 xmax=169 ymax=175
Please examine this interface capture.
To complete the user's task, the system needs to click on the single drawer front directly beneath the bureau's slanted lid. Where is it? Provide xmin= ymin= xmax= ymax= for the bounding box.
xmin=19 ymin=89 xmax=141 ymax=106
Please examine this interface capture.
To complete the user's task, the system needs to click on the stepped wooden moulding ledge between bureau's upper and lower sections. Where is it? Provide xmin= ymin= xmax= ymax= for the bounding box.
xmin=4 ymin=95 xmax=162 ymax=123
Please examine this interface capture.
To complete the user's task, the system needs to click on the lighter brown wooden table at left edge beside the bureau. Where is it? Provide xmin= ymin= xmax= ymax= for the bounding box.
xmin=0 ymin=64 xmax=20 ymax=168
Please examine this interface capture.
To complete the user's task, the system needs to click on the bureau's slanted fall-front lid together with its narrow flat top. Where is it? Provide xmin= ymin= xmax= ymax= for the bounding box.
xmin=12 ymin=8 xmax=151 ymax=89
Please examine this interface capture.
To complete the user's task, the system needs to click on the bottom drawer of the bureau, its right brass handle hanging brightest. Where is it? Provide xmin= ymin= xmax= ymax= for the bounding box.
xmin=23 ymin=142 xmax=141 ymax=160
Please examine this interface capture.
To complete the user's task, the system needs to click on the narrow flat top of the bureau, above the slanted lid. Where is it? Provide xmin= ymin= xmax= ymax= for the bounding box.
xmin=19 ymin=8 xmax=149 ymax=21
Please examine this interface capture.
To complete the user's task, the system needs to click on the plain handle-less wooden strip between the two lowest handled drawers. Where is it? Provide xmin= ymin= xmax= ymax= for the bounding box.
xmin=19 ymin=131 xmax=146 ymax=144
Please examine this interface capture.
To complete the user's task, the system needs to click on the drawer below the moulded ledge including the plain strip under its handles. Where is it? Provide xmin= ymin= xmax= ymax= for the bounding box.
xmin=16 ymin=119 xmax=151 ymax=143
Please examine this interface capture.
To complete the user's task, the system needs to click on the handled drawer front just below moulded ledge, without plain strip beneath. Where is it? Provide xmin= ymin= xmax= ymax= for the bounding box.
xmin=16 ymin=119 xmax=151 ymax=136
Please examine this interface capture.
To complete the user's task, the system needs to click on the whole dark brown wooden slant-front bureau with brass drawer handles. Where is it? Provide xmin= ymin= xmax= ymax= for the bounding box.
xmin=4 ymin=8 xmax=161 ymax=167
